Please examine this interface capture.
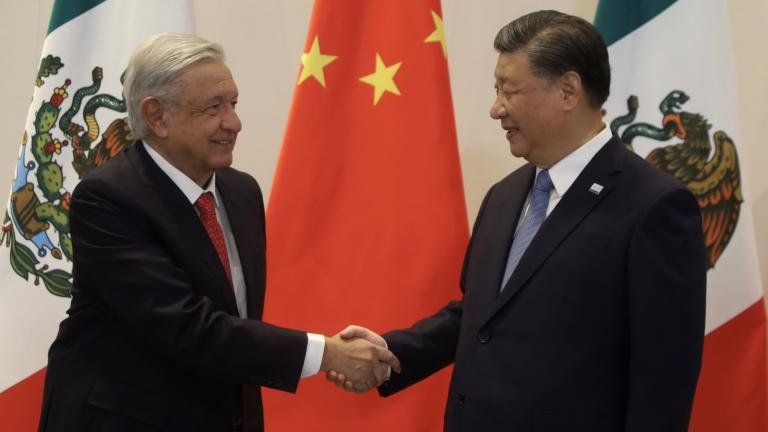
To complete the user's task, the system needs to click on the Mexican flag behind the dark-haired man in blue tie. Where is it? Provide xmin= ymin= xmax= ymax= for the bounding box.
xmin=595 ymin=0 xmax=768 ymax=432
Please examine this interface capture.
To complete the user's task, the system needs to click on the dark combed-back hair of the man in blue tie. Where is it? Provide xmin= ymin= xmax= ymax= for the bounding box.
xmin=493 ymin=10 xmax=611 ymax=108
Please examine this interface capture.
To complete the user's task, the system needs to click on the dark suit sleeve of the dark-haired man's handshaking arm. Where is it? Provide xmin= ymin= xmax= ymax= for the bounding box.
xmin=379 ymin=186 xmax=495 ymax=396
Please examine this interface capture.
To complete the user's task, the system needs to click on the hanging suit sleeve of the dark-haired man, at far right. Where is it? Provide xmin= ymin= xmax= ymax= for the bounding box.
xmin=626 ymin=188 xmax=707 ymax=432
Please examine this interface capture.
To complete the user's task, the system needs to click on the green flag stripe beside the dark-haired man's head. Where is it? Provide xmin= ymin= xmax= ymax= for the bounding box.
xmin=595 ymin=0 xmax=677 ymax=45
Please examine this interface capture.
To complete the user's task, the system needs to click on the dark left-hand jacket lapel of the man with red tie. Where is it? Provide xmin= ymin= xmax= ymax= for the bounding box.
xmin=128 ymin=142 xmax=237 ymax=315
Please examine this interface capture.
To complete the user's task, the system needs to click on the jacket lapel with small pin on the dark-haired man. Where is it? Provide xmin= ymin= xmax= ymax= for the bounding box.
xmin=483 ymin=138 xmax=626 ymax=321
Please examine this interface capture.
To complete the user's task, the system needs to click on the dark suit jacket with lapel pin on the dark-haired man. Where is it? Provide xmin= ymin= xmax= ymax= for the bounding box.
xmin=380 ymin=138 xmax=706 ymax=432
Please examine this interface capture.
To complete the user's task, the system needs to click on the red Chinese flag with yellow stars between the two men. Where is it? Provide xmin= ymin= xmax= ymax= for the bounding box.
xmin=265 ymin=0 xmax=468 ymax=432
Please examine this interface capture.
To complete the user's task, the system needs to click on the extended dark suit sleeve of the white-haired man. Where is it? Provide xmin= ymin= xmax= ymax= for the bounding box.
xmin=70 ymin=179 xmax=307 ymax=391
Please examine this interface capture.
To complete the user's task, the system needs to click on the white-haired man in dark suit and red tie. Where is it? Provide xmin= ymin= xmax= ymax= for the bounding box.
xmin=40 ymin=33 xmax=399 ymax=432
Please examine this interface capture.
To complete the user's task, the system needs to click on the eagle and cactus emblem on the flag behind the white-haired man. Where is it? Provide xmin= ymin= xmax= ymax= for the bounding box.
xmin=0 ymin=55 xmax=133 ymax=297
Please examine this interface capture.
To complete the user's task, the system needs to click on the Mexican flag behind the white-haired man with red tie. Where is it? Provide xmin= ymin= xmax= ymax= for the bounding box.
xmin=0 ymin=0 xmax=194 ymax=431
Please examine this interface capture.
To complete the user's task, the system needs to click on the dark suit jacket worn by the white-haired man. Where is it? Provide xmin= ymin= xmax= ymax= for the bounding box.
xmin=40 ymin=143 xmax=307 ymax=432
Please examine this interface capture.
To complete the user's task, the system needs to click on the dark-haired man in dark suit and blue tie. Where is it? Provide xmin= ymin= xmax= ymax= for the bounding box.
xmin=328 ymin=11 xmax=706 ymax=432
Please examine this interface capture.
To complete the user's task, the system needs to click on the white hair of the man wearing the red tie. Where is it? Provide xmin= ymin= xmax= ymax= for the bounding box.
xmin=123 ymin=33 xmax=224 ymax=139
